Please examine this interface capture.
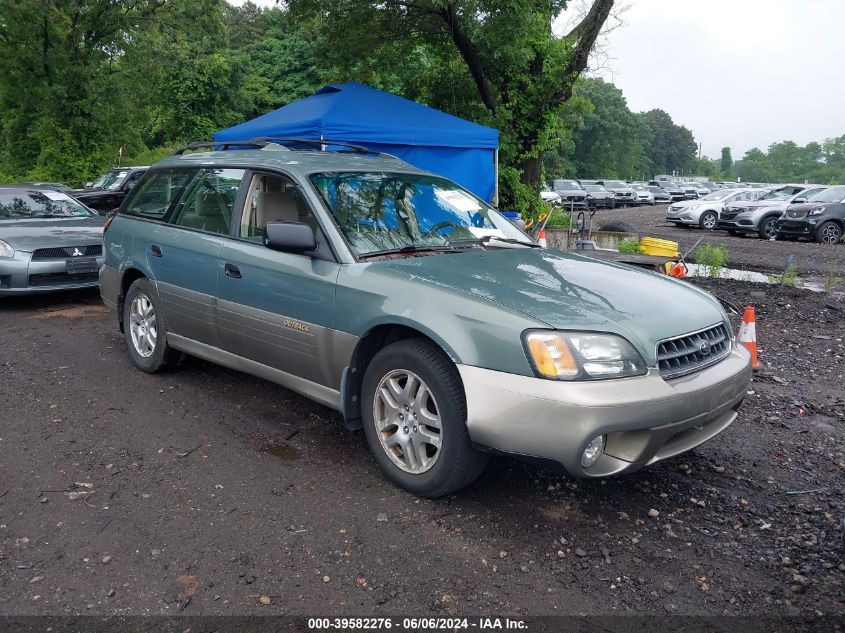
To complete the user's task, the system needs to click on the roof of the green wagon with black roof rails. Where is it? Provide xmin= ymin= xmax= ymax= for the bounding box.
xmin=154 ymin=148 xmax=422 ymax=175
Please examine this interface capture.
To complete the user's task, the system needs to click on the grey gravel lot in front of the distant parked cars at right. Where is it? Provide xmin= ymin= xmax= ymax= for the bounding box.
xmin=580 ymin=205 xmax=845 ymax=279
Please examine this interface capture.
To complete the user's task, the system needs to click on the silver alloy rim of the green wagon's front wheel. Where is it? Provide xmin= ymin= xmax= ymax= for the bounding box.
xmin=373 ymin=369 xmax=443 ymax=475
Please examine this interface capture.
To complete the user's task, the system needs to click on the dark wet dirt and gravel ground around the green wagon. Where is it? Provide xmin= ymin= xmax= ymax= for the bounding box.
xmin=0 ymin=278 xmax=845 ymax=630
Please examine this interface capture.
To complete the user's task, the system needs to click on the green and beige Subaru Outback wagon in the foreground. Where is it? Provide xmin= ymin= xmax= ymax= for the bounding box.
xmin=100 ymin=140 xmax=751 ymax=497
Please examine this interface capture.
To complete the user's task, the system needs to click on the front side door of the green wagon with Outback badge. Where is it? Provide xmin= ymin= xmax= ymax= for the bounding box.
xmin=218 ymin=172 xmax=342 ymax=389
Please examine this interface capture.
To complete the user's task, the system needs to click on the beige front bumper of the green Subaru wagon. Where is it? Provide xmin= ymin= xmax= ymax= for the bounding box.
xmin=458 ymin=346 xmax=751 ymax=477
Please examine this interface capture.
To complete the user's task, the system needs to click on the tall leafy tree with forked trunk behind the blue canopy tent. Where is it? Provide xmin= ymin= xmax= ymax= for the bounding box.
xmin=288 ymin=0 xmax=614 ymax=210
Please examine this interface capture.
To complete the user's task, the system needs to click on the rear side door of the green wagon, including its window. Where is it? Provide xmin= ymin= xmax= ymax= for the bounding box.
xmin=139 ymin=168 xmax=245 ymax=347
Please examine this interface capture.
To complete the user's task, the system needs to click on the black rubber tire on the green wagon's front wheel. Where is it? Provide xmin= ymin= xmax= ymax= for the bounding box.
xmin=361 ymin=338 xmax=488 ymax=498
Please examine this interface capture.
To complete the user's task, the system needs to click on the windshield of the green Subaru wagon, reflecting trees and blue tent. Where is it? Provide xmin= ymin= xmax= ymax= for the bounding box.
xmin=311 ymin=172 xmax=531 ymax=257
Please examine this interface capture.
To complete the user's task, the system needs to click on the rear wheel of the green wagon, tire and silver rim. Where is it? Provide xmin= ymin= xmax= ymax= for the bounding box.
xmin=123 ymin=278 xmax=180 ymax=373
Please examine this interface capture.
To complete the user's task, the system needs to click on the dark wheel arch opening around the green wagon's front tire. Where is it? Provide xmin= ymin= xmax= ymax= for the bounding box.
xmin=340 ymin=323 xmax=463 ymax=430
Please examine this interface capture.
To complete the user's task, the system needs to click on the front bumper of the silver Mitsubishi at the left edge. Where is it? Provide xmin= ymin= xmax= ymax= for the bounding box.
xmin=0 ymin=252 xmax=105 ymax=296
